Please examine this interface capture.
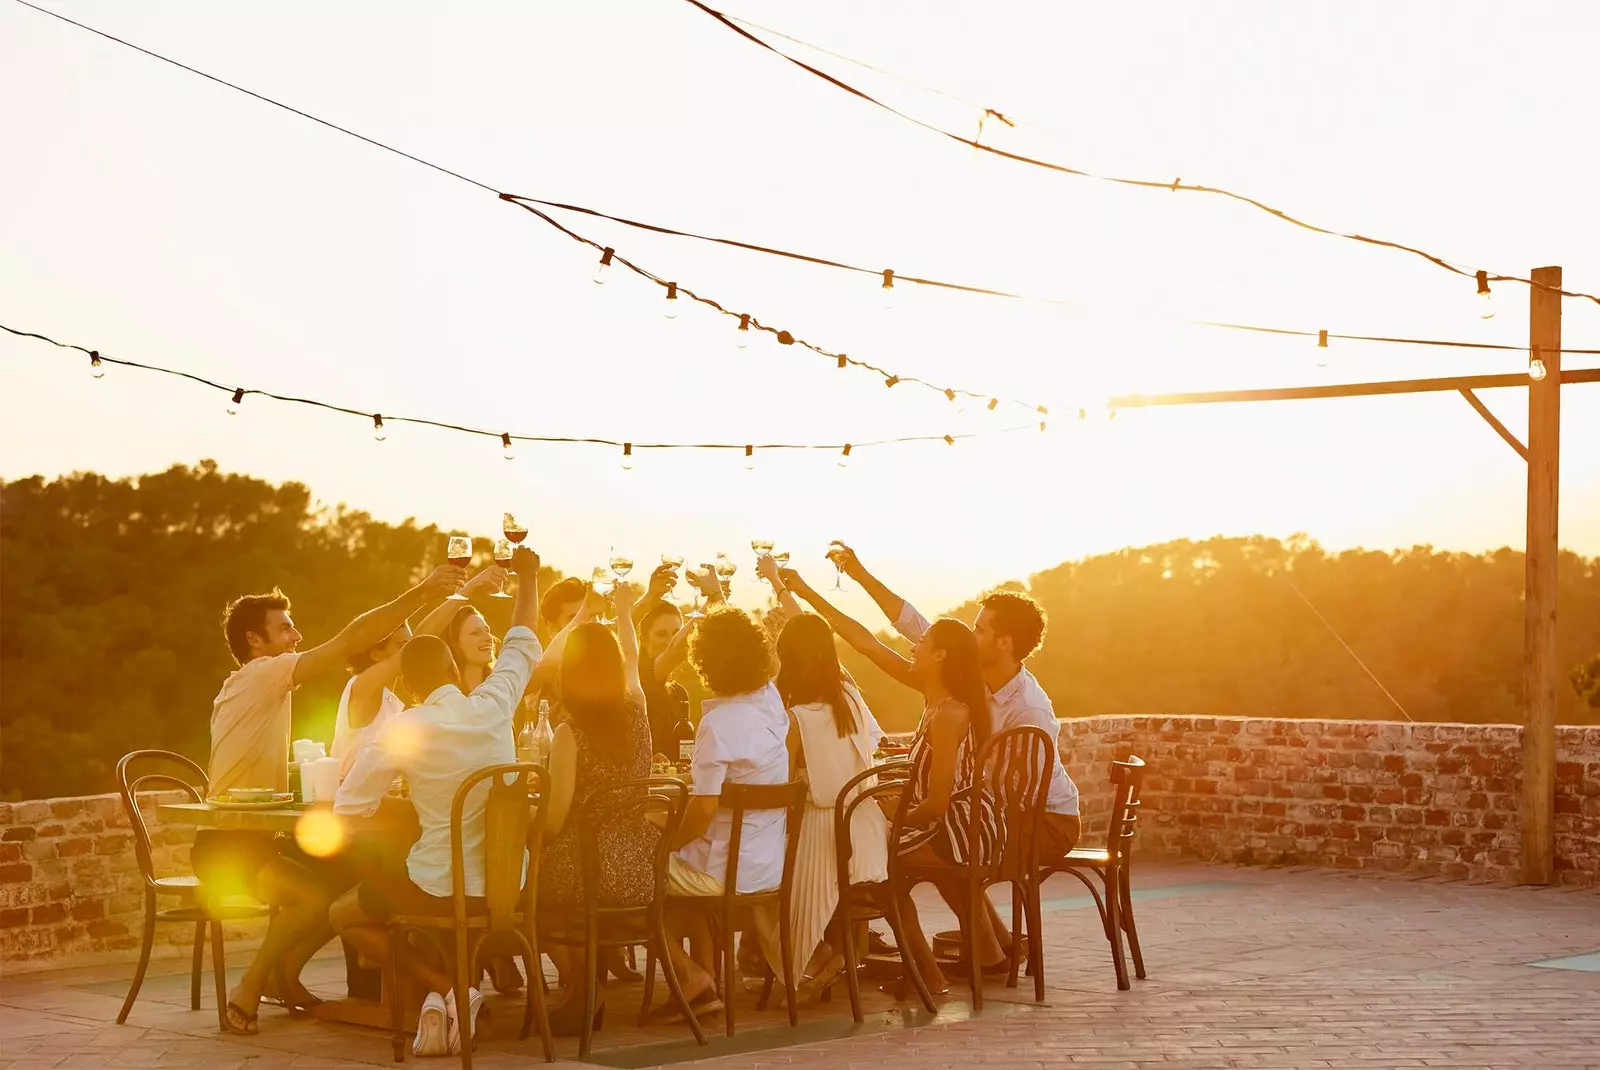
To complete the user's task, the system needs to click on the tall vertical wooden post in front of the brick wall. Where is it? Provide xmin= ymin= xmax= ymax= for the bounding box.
xmin=1522 ymin=267 xmax=1562 ymax=884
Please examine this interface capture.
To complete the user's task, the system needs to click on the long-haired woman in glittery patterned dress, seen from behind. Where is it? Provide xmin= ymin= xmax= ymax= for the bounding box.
xmin=539 ymin=585 xmax=661 ymax=1036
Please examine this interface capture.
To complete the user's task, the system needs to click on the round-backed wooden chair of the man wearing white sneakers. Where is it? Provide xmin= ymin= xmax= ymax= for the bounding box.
xmin=384 ymin=761 xmax=555 ymax=1070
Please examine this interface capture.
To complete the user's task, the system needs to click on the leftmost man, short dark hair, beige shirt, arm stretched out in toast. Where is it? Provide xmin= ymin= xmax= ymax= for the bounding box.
xmin=204 ymin=565 xmax=466 ymax=1033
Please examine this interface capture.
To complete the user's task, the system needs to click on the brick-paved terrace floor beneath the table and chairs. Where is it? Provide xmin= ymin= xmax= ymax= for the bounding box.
xmin=0 ymin=864 xmax=1600 ymax=1070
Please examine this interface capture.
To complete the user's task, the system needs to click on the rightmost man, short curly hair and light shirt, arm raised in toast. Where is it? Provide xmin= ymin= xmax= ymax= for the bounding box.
xmin=838 ymin=547 xmax=1082 ymax=950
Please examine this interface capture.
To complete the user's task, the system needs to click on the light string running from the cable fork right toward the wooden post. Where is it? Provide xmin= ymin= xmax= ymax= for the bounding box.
xmin=501 ymin=194 xmax=1600 ymax=356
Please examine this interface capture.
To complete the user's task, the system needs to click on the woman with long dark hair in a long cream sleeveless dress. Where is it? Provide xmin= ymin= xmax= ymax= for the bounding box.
xmin=776 ymin=613 xmax=888 ymax=988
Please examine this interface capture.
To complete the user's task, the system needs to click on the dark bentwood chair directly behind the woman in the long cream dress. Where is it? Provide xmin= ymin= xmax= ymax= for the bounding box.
xmin=822 ymin=761 xmax=939 ymax=1024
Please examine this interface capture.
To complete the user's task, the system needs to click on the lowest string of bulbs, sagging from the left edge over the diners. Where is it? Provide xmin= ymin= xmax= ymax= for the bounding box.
xmin=0 ymin=323 xmax=1048 ymax=459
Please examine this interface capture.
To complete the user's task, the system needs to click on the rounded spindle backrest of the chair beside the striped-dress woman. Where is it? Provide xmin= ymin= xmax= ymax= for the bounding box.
xmin=966 ymin=725 xmax=1056 ymax=881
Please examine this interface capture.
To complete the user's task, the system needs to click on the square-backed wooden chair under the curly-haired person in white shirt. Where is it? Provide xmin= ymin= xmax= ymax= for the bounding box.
xmin=646 ymin=781 xmax=810 ymax=1036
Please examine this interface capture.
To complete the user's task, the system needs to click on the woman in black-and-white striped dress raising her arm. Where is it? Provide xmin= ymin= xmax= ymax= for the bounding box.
xmin=782 ymin=569 xmax=1005 ymax=992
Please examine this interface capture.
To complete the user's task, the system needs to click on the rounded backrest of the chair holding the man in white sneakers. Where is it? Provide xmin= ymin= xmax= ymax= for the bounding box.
xmin=450 ymin=761 xmax=549 ymax=931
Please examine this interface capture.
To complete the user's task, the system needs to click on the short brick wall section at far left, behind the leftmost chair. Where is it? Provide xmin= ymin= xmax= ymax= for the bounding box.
xmin=0 ymin=792 xmax=261 ymax=972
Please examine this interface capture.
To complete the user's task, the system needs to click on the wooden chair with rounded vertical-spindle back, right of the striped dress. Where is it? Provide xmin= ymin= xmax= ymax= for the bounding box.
xmin=893 ymin=726 xmax=1054 ymax=1011
